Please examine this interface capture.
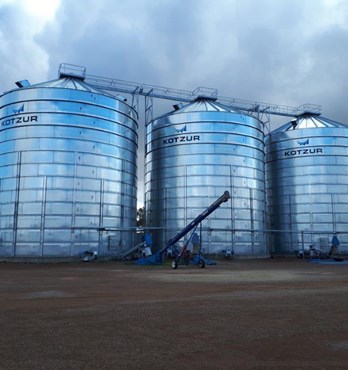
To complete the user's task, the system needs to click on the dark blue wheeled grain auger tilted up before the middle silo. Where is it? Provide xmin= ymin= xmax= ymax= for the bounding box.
xmin=136 ymin=190 xmax=231 ymax=269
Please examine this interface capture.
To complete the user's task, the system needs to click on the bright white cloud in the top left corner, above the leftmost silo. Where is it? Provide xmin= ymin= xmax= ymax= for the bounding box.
xmin=0 ymin=0 xmax=59 ymax=91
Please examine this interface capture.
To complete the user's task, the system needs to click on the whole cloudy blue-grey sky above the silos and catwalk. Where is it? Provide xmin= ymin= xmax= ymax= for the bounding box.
xmin=0 ymin=0 xmax=348 ymax=202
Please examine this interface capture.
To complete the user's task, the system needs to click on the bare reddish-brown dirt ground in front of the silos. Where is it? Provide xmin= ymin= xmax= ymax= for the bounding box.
xmin=0 ymin=259 xmax=348 ymax=370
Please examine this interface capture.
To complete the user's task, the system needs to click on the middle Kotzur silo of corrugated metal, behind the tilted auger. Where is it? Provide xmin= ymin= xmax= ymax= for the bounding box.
xmin=145 ymin=98 xmax=268 ymax=255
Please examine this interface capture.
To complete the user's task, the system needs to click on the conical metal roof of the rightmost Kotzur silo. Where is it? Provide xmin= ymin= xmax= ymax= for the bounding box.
xmin=272 ymin=114 xmax=347 ymax=133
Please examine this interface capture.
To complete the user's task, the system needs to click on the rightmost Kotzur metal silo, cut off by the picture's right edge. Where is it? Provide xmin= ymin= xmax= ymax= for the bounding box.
xmin=266 ymin=114 xmax=348 ymax=254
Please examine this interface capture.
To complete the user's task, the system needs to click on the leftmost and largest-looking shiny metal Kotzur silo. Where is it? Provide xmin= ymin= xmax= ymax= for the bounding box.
xmin=0 ymin=75 xmax=137 ymax=258
